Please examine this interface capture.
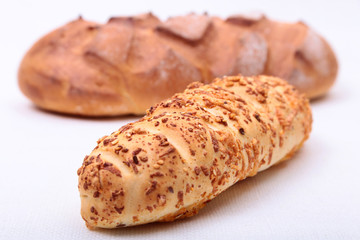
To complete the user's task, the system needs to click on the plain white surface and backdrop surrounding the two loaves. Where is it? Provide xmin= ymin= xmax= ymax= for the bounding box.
xmin=0 ymin=0 xmax=360 ymax=240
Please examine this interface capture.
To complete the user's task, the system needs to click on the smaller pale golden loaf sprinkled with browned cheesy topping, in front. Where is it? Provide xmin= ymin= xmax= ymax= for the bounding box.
xmin=78 ymin=76 xmax=312 ymax=228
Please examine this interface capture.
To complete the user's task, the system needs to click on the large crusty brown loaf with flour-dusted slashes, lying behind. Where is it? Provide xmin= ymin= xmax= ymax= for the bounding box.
xmin=18 ymin=14 xmax=337 ymax=116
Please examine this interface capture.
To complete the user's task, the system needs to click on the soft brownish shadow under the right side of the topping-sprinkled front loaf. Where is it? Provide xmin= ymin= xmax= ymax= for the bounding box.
xmin=93 ymin=146 xmax=303 ymax=237
